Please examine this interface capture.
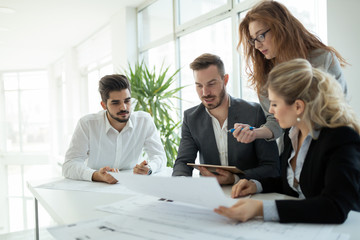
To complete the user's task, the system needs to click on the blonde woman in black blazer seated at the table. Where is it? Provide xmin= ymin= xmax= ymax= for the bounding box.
xmin=215 ymin=59 xmax=360 ymax=223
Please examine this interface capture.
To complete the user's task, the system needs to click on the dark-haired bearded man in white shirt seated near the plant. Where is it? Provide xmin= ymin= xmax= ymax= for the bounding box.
xmin=62 ymin=74 xmax=166 ymax=183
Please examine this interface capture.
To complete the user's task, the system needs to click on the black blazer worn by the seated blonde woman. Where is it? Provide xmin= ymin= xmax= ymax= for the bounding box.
xmin=260 ymin=127 xmax=360 ymax=223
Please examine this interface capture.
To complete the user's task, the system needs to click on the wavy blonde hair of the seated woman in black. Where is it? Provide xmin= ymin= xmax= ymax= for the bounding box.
xmin=267 ymin=58 xmax=360 ymax=134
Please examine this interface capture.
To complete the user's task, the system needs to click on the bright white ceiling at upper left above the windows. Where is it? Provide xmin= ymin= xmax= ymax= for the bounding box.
xmin=0 ymin=0 xmax=145 ymax=71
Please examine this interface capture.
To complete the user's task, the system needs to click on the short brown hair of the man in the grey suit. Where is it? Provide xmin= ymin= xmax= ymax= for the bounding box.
xmin=190 ymin=53 xmax=225 ymax=77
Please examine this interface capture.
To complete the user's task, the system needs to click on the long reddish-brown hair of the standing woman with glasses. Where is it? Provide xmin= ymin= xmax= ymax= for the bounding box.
xmin=237 ymin=0 xmax=347 ymax=95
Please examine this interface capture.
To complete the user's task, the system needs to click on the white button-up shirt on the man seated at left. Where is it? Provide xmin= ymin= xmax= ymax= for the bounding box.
xmin=63 ymin=110 xmax=166 ymax=181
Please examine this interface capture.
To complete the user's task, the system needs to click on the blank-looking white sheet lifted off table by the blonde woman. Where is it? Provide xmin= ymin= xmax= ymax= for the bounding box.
xmin=110 ymin=173 xmax=237 ymax=209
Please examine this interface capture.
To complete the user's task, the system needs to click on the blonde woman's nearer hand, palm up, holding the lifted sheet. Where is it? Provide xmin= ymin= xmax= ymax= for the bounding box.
xmin=214 ymin=198 xmax=264 ymax=222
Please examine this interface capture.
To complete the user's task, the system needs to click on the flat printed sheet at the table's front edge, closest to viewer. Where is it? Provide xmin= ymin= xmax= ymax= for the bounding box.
xmin=48 ymin=215 xmax=238 ymax=240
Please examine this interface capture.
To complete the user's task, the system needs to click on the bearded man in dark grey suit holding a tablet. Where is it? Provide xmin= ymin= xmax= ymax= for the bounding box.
xmin=172 ymin=53 xmax=279 ymax=184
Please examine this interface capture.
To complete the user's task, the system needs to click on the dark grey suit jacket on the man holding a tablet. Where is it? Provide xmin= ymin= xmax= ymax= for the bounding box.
xmin=172 ymin=97 xmax=279 ymax=179
